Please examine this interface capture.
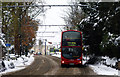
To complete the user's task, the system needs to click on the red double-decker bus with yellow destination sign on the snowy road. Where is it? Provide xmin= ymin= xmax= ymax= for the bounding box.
xmin=61 ymin=30 xmax=82 ymax=66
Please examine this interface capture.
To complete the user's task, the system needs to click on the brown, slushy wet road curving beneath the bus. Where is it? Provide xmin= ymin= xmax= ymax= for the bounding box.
xmin=2 ymin=55 xmax=117 ymax=77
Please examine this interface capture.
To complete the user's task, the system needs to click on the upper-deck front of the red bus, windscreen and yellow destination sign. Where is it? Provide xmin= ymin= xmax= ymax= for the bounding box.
xmin=62 ymin=31 xmax=81 ymax=46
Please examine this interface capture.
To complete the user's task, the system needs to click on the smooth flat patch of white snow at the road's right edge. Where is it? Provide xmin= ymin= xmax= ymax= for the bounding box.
xmin=89 ymin=64 xmax=118 ymax=75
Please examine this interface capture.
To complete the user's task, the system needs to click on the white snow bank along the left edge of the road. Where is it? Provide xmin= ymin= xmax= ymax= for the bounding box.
xmin=0 ymin=55 xmax=34 ymax=75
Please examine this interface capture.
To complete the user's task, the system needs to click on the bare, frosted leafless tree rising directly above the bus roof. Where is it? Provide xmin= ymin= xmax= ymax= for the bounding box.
xmin=62 ymin=2 xmax=85 ymax=29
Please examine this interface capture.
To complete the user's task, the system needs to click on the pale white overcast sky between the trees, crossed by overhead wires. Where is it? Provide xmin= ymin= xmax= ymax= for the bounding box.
xmin=36 ymin=0 xmax=70 ymax=44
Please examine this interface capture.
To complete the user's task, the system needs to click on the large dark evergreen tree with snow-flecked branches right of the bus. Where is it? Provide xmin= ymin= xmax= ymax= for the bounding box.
xmin=79 ymin=2 xmax=120 ymax=57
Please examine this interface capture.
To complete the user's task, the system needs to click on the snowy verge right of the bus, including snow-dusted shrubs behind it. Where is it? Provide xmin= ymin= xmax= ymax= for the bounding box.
xmin=84 ymin=56 xmax=118 ymax=76
